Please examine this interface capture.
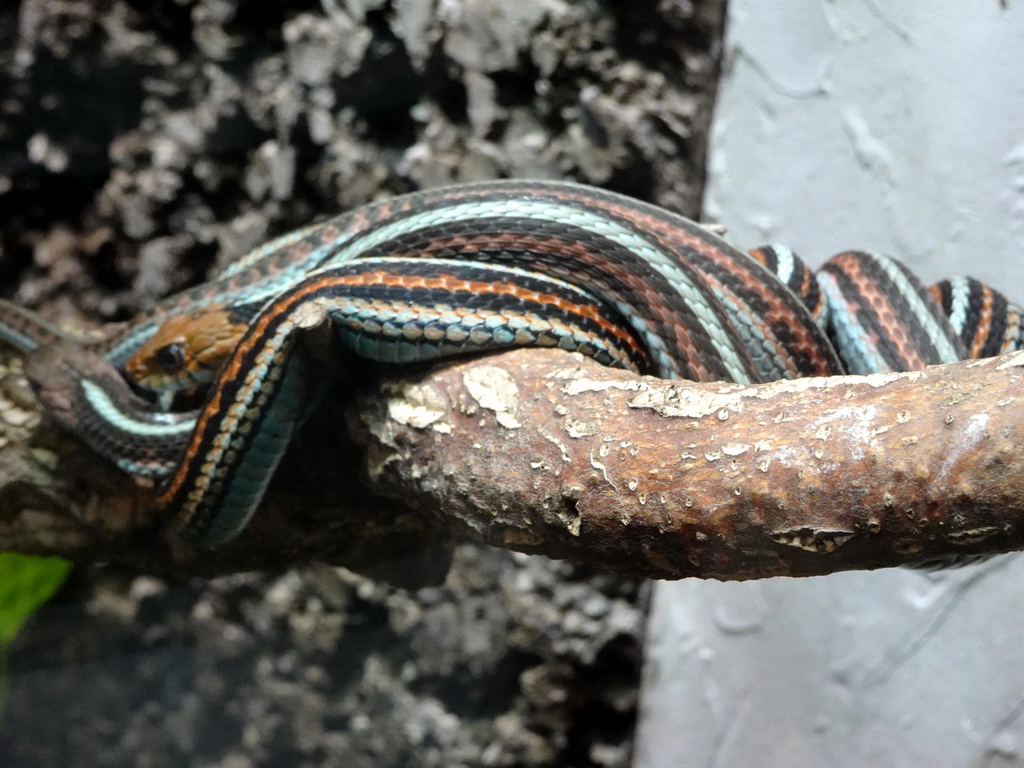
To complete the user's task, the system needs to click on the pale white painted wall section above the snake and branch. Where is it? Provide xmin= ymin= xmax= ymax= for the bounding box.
xmin=705 ymin=0 xmax=1024 ymax=290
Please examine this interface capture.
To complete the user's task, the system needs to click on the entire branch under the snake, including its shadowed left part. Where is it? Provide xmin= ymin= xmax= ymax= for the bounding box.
xmin=0 ymin=349 xmax=1024 ymax=583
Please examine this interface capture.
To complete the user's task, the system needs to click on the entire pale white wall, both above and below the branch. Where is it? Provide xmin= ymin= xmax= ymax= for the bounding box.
xmin=635 ymin=6 xmax=1024 ymax=768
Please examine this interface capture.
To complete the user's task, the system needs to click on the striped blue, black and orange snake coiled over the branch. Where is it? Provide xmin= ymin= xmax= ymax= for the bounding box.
xmin=0 ymin=181 xmax=1024 ymax=545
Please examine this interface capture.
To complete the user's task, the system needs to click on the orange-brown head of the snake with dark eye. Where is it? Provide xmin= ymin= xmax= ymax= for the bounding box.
xmin=125 ymin=306 xmax=246 ymax=410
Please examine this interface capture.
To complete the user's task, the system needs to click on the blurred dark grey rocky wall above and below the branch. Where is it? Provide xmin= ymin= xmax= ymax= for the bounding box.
xmin=0 ymin=0 xmax=724 ymax=768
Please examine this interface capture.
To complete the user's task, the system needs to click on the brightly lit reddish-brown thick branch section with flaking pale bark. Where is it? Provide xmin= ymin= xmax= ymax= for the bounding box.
xmin=359 ymin=351 xmax=1024 ymax=580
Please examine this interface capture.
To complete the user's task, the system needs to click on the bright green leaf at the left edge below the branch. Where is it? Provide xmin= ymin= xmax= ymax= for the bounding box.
xmin=0 ymin=552 xmax=71 ymax=647
